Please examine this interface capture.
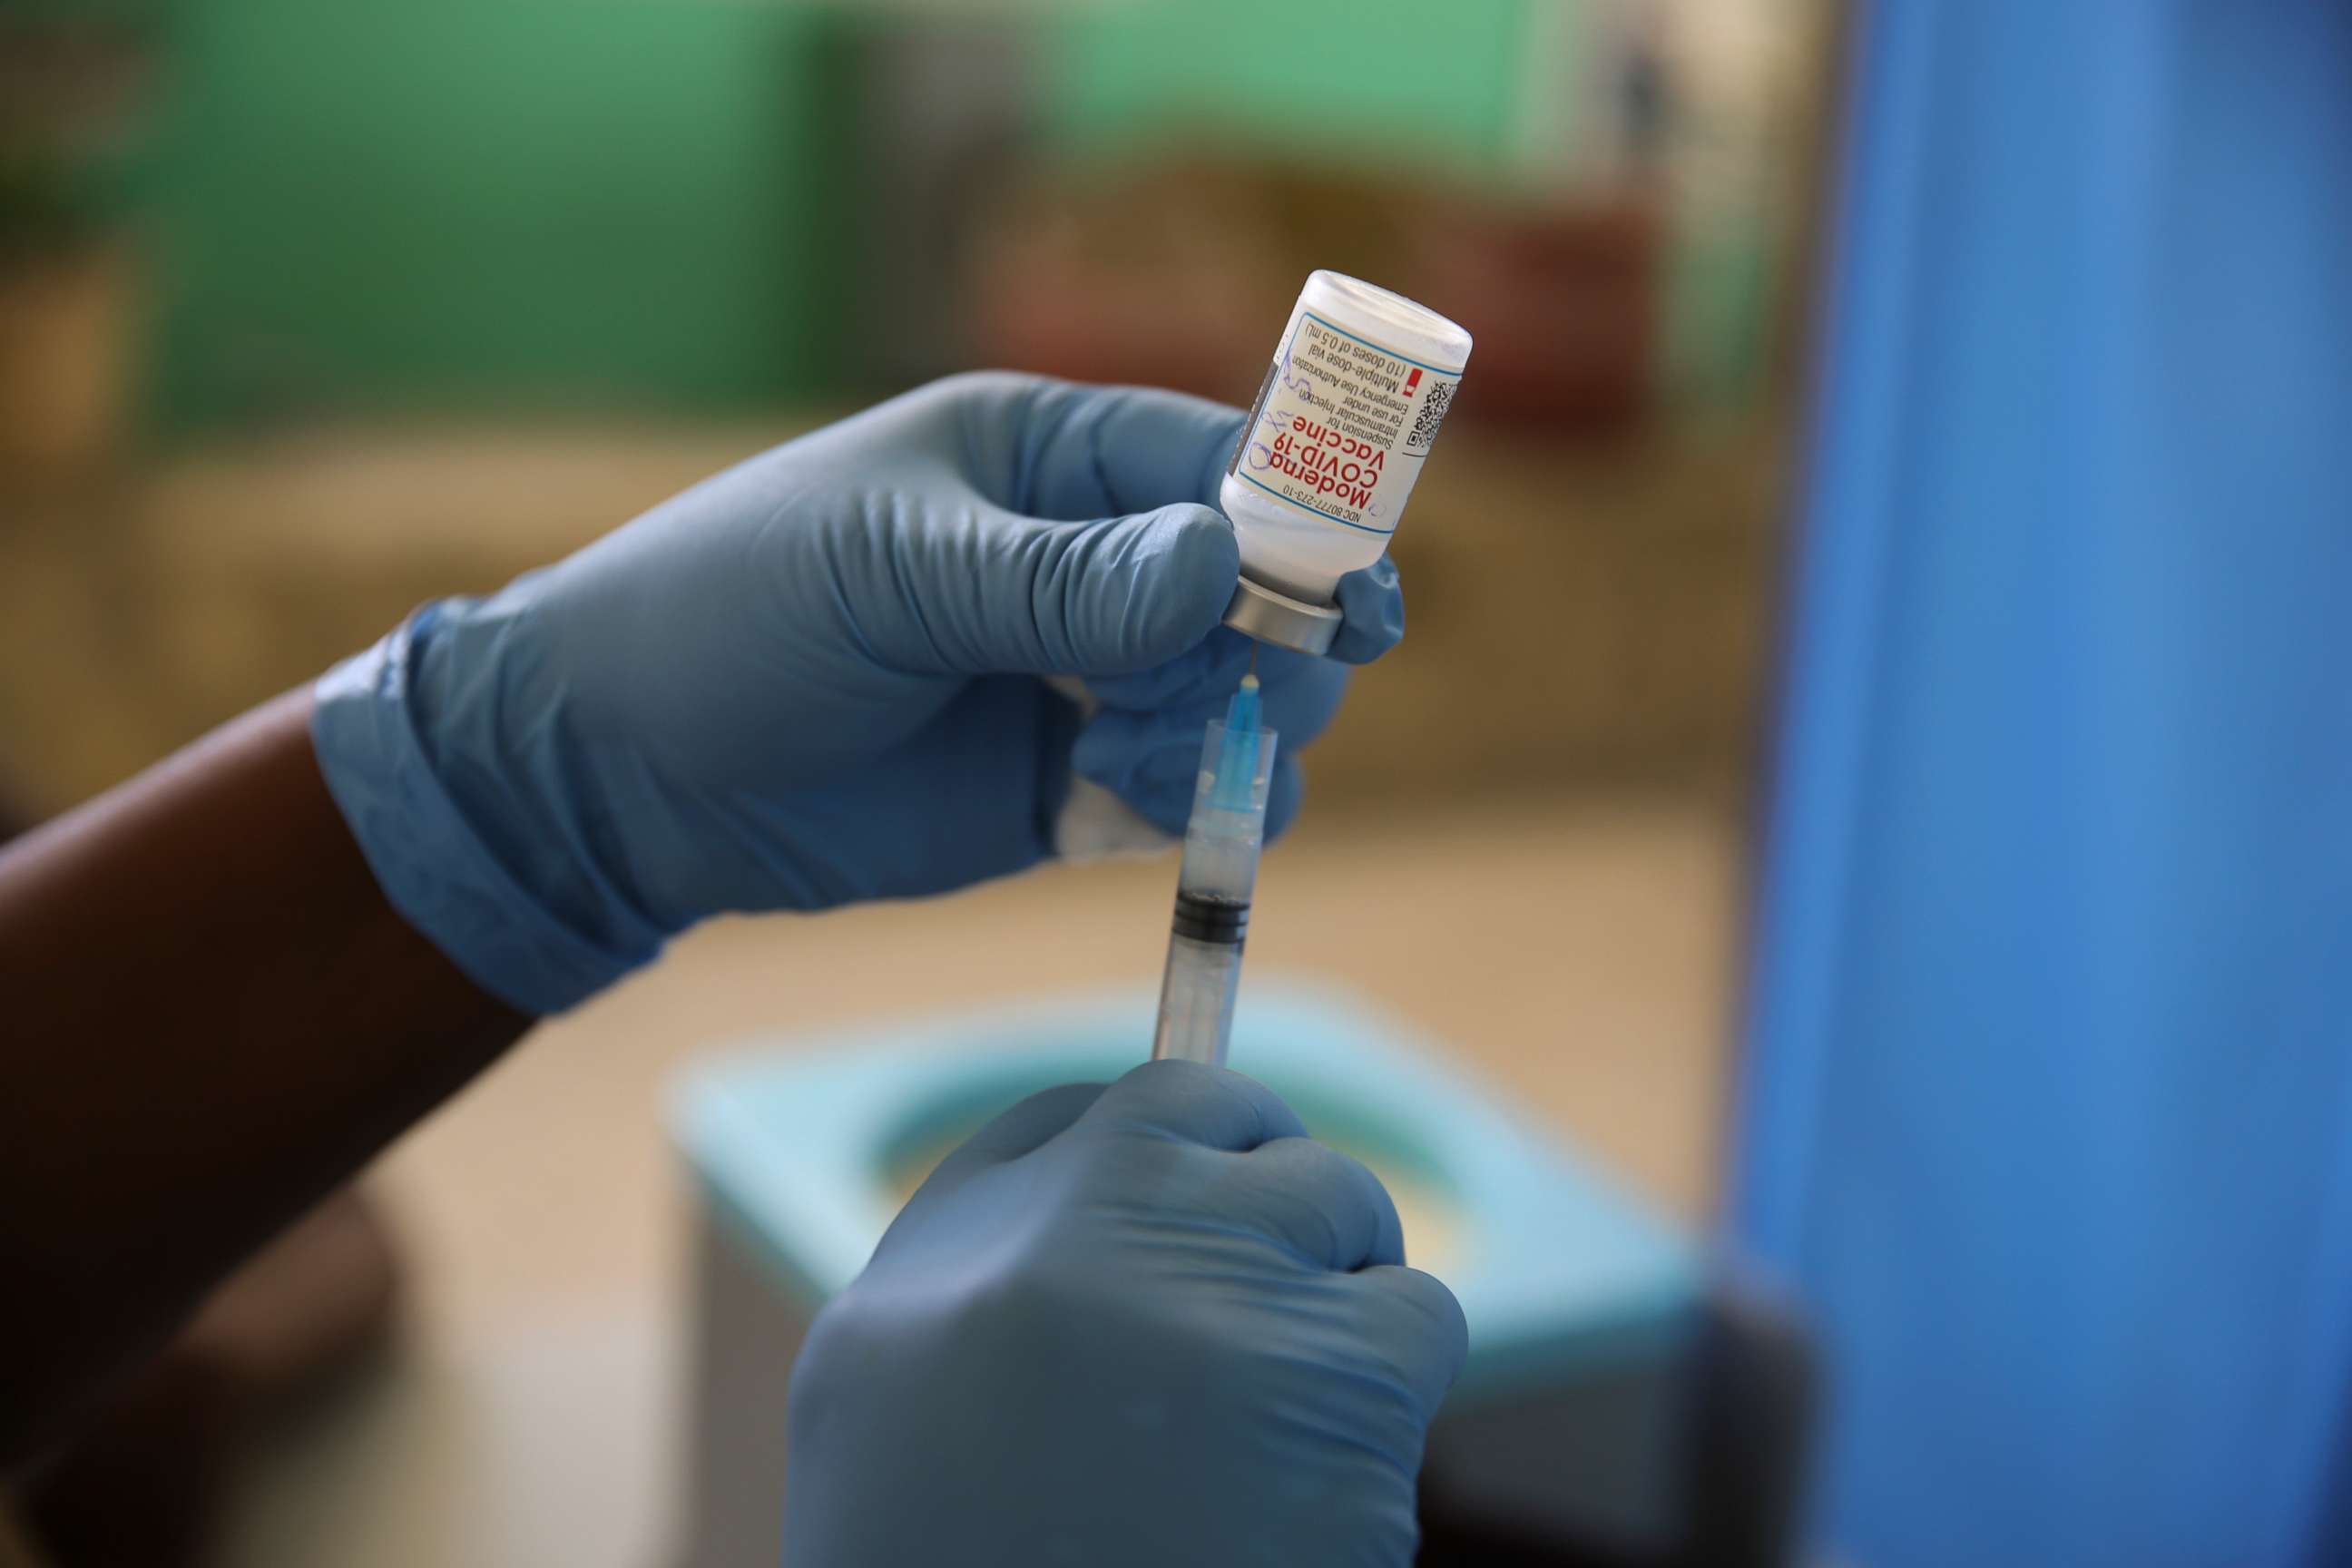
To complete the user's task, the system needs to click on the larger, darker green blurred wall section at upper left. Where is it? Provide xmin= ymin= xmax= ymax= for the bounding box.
xmin=151 ymin=0 xmax=845 ymax=430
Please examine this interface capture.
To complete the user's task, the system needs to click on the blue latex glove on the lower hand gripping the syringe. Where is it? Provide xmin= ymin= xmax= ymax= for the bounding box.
xmin=786 ymin=1063 xmax=1467 ymax=1568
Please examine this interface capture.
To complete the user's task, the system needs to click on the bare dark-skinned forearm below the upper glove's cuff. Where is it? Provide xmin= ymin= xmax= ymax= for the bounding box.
xmin=0 ymin=693 xmax=529 ymax=1465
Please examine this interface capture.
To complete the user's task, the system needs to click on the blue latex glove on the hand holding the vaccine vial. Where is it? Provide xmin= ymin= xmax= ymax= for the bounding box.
xmin=313 ymin=374 xmax=1404 ymax=1014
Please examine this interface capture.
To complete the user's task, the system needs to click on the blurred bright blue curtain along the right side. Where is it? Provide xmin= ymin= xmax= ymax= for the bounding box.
xmin=1731 ymin=0 xmax=2352 ymax=1568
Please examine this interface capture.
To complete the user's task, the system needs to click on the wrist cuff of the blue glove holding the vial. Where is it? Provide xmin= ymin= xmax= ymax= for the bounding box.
xmin=310 ymin=606 xmax=661 ymax=1015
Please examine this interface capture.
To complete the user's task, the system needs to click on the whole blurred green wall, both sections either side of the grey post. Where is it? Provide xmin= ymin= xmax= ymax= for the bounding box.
xmin=146 ymin=0 xmax=1590 ymax=433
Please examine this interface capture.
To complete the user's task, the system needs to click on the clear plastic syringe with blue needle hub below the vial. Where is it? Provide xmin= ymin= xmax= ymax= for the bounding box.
xmin=1152 ymin=675 xmax=1275 ymax=1067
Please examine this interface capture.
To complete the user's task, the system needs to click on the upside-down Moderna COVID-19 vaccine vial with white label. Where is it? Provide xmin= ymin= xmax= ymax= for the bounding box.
xmin=1219 ymin=273 xmax=1470 ymax=653
